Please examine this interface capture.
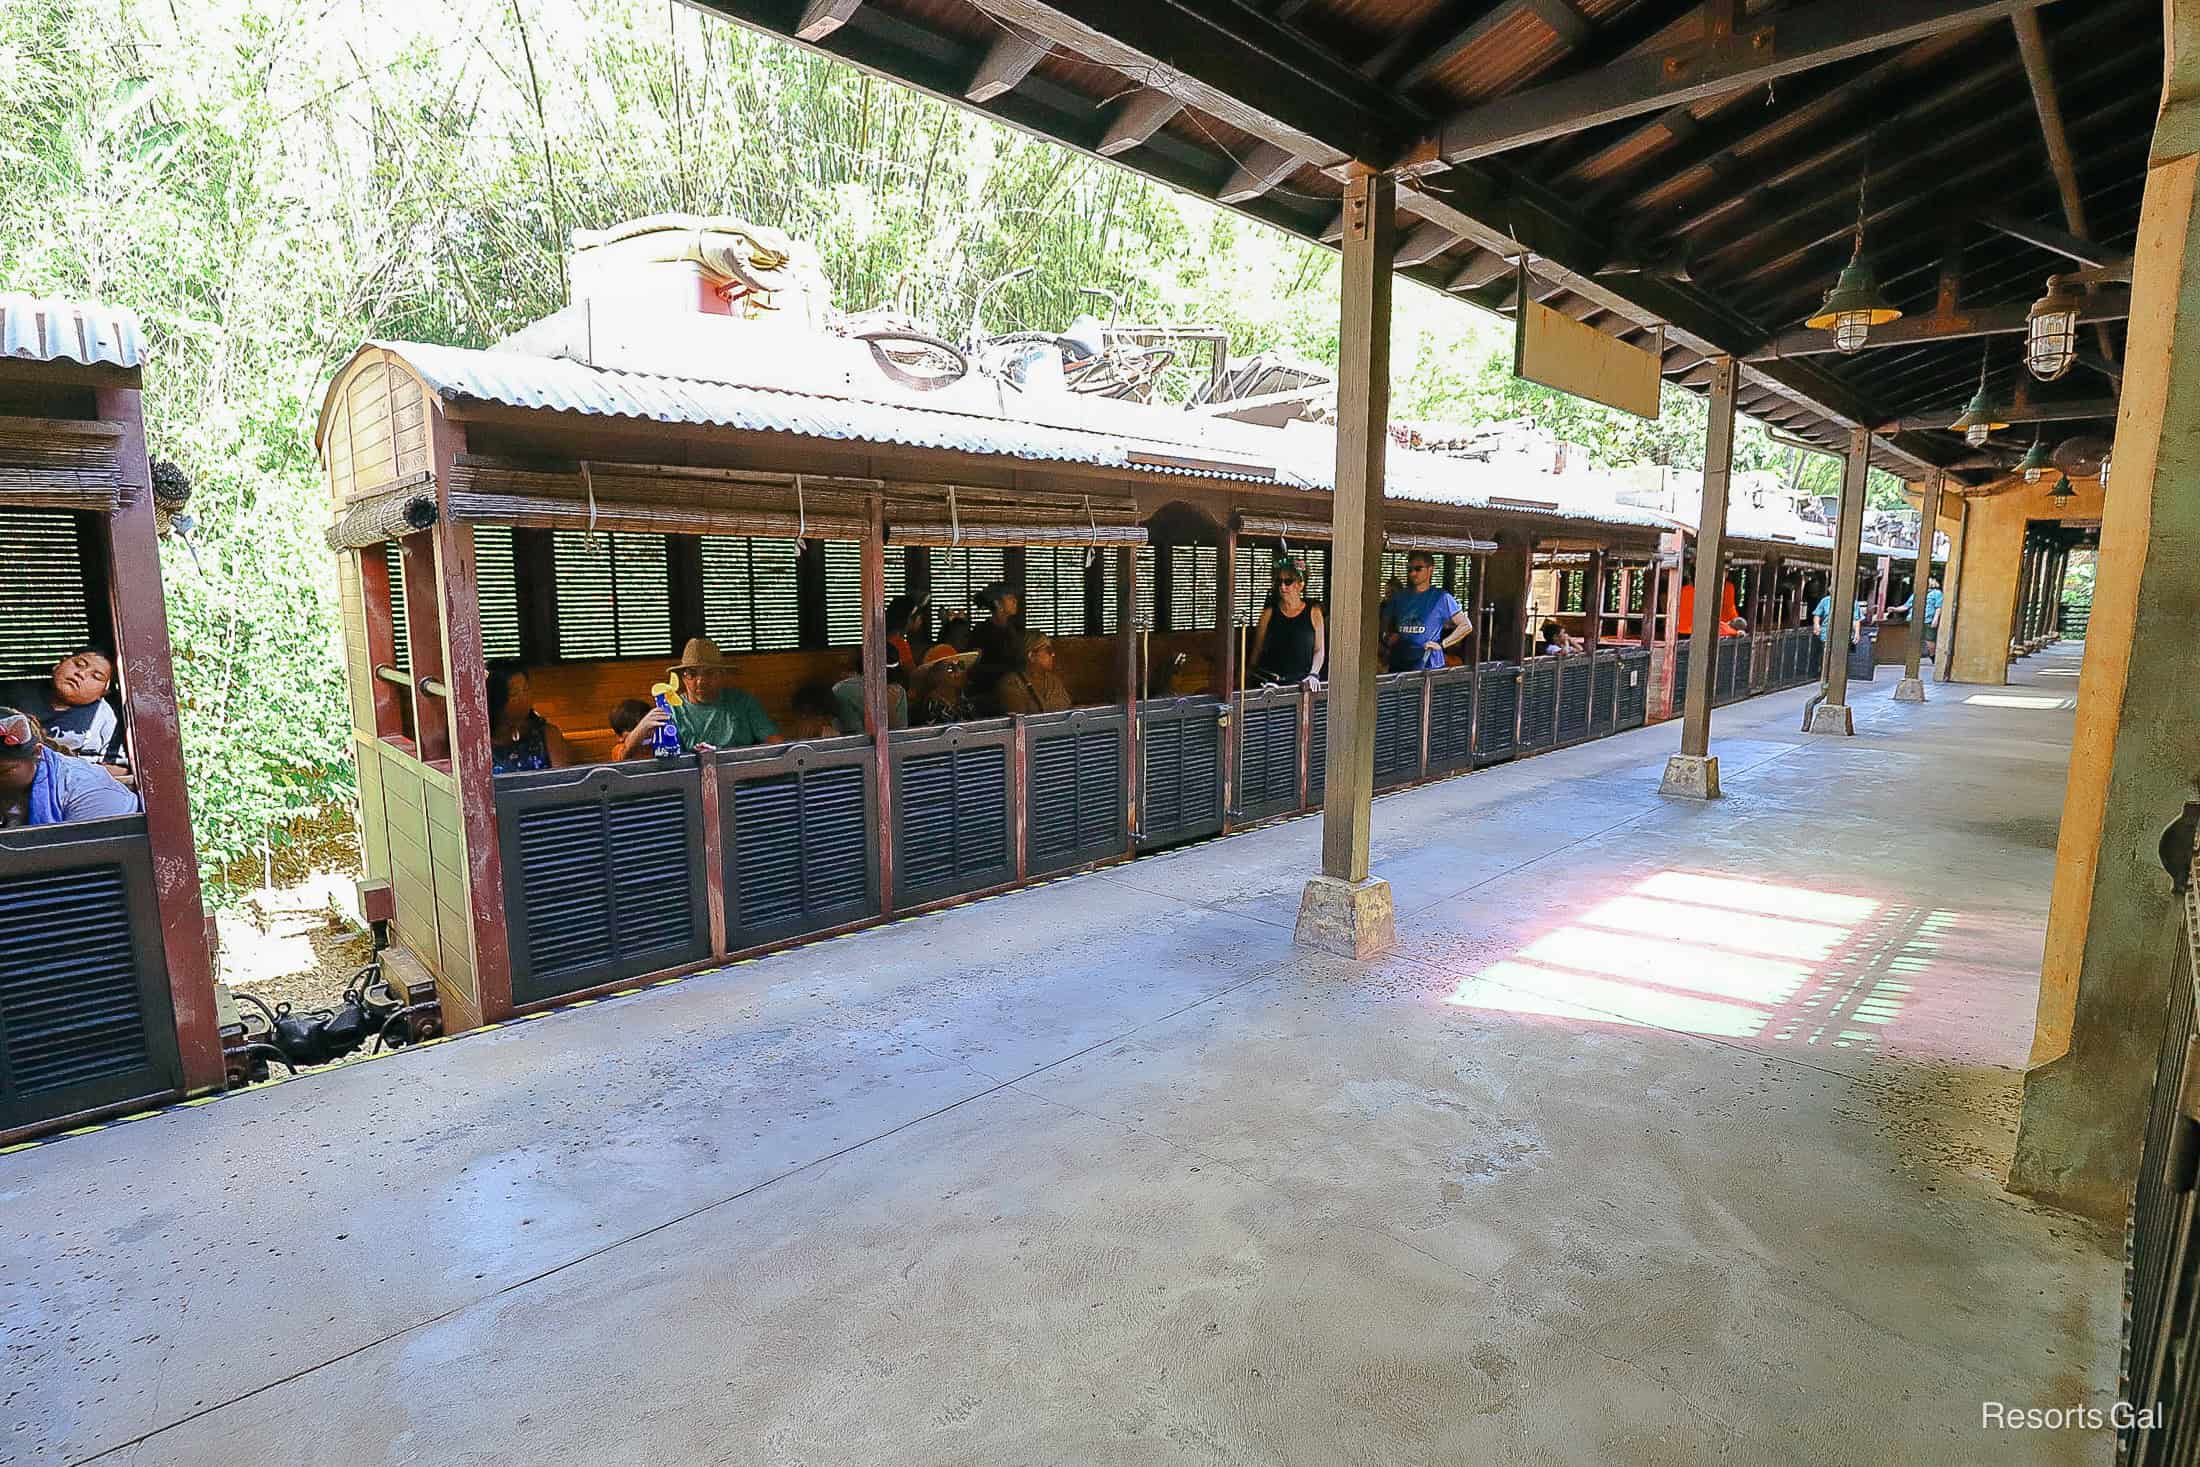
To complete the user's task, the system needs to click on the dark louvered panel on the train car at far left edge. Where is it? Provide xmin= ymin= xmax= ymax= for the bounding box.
xmin=0 ymin=867 xmax=154 ymax=1099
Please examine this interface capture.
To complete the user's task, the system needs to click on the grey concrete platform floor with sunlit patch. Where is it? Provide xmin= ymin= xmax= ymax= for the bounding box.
xmin=0 ymin=653 xmax=2119 ymax=1467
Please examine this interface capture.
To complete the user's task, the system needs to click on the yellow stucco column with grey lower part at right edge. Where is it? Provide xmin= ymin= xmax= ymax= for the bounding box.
xmin=2009 ymin=17 xmax=2200 ymax=1218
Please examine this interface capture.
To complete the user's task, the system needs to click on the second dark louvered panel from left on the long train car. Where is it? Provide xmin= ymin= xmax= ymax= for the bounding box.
xmin=726 ymin=763 xmax=876 ymax=948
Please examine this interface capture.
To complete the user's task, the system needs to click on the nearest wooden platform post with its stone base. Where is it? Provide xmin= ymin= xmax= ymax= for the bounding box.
xmin=1298 ymin=167 xmax=1397 ymax=959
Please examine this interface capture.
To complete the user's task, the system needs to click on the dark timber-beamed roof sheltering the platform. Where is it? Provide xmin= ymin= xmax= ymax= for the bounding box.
xmin=697 ymin=0 xmax=2163 ymax=486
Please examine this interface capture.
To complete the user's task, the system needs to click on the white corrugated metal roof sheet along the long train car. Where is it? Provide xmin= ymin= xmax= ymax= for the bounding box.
xmin=370 ymin=341 xmax=1672 ymax=530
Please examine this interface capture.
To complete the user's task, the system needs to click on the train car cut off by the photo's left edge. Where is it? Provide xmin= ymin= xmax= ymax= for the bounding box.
xmin=0 ymin=295 xmax=224 ymax=1150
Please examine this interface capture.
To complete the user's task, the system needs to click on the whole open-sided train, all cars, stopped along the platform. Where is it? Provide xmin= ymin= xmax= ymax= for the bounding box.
xmin=0 ymin=278 xmax=1936 ymax=1146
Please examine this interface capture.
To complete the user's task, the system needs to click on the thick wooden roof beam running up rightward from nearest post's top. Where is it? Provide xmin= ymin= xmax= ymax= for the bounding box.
xmin=1428 ymin=0 xmax=2048 ymax=163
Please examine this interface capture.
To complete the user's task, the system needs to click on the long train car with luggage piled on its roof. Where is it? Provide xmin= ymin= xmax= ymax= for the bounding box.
xmin=319 ymin=224 xmax=1909 ymax=1032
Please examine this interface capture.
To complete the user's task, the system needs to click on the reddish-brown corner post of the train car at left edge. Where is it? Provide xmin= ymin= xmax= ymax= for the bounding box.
xmin=92 ymin=384 xmax=227 ymax=1095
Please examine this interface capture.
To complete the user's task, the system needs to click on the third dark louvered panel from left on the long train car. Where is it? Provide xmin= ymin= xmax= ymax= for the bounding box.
xmin=893 ymin=741 xmax=1016 ymax=906
